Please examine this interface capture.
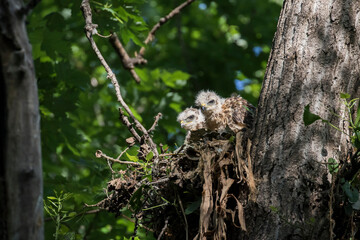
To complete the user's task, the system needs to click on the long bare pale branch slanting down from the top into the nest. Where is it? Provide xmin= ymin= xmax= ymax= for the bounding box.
xmin=80 ymin=0 xmax=159 ymax=167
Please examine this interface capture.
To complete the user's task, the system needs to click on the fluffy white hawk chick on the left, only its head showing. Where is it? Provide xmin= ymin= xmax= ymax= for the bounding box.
xmin=177 ymin=108 xmax=205 ymax=131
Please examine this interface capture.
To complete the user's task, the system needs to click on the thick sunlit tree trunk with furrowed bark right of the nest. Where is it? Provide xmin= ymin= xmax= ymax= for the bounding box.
xmin=247 ymin=0 xmax=360 ymax=239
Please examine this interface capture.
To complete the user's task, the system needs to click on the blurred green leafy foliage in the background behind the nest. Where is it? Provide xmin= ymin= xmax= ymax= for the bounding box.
xmin=27 ymin=0 xmax=282 ymax=239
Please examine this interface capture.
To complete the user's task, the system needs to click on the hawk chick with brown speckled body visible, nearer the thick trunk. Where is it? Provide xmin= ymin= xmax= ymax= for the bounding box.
xmin=195 ymin=91 xmax=255 ymax=133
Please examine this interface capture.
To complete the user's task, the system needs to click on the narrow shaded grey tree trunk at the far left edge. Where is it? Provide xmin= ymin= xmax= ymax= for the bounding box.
xmin=0 ymin=0 xmax=44 ymax=240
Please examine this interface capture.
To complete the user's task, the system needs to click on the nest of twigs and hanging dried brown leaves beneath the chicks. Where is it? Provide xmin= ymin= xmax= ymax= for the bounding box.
xmin=92 ymin=130 xmax=256 ymax=239
